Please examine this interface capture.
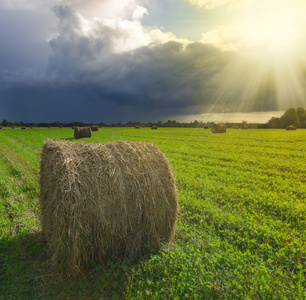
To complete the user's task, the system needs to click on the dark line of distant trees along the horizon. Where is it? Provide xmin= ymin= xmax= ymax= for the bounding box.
xmin=1 ymin=107 xmax=306 ymax=128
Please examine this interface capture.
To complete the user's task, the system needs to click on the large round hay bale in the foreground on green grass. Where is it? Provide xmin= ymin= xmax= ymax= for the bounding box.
xmin=40 ymin=140 xmax=178 ymax=276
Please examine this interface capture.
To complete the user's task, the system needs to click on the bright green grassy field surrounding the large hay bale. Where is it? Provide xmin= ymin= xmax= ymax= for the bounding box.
xmin=0 ymin=128 xmax=306 ymax=299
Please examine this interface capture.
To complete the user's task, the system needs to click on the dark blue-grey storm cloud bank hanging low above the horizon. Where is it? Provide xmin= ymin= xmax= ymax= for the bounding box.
xmin=1 ymin=6 xmax=234 ymax=121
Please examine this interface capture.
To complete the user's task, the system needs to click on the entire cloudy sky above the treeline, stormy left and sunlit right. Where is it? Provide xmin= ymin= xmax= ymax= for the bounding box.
xmin=0 ymin=0 xmax=306 ymax=123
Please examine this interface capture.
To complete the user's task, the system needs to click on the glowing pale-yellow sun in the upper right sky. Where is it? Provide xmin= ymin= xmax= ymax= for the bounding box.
xmin=236 ymin=0 xmax=306 ymax=55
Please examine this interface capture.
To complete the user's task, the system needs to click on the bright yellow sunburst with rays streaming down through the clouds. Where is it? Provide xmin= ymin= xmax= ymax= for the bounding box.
xmin=204 ymin=0 xmax=306 ymax=111
